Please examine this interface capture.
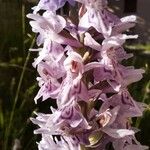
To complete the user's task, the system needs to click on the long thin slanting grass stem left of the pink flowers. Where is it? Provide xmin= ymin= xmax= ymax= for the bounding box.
xmin=4 ymin=38 xmax=35 ymax=150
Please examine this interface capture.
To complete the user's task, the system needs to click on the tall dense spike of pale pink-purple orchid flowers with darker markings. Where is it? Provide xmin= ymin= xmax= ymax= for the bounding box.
xmin=27 ymin=0 xmax=146 ymax=150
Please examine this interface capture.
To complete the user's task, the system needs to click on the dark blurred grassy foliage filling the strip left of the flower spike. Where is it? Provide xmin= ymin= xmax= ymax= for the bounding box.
xmin=0 ymin=1 xmax=38 ymax=150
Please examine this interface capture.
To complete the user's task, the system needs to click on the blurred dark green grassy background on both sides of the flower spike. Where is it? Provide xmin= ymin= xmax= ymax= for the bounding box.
xmin=0 ymin=0 xmax=150 ymax=150
